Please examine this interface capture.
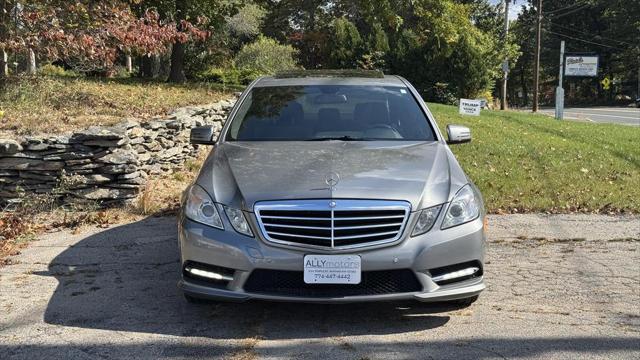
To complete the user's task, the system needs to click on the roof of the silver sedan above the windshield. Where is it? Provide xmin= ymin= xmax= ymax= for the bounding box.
xmin=254 ymin=71 xmax=406 ymax=87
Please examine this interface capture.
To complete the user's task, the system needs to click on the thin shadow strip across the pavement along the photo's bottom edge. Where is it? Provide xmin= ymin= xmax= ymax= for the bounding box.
xmin=0 ymin=337 xmax=638 ymax=360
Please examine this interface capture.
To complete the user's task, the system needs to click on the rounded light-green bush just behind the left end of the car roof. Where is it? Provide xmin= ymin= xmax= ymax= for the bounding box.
xmin=235 ymin=36 xmax=298 ymax=75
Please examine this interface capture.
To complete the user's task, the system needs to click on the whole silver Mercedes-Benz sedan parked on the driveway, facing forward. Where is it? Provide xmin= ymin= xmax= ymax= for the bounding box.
xmin=179 ymin=72 xmax=485 ymax=303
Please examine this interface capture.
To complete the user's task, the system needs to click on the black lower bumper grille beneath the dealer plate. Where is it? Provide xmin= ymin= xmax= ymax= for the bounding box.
xmin=244 ymin=269 xmax=422 ymax=298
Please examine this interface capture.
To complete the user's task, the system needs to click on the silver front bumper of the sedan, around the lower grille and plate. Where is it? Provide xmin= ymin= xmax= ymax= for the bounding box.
xmin=179 ymin=214 xmax=485 ymax=303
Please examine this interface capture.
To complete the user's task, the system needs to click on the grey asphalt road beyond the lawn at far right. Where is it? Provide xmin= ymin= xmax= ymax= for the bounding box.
xmin=540 ymin=107 xmax=640 ymax=126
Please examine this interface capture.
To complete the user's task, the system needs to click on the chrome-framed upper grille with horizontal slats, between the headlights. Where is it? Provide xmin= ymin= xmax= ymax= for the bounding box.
xmin=255 ymin=199 xmax=411 ymax=249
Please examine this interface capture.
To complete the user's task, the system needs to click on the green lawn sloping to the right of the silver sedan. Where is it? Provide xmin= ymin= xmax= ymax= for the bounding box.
xmin=429 ymin=104 xmax=640 ymax=213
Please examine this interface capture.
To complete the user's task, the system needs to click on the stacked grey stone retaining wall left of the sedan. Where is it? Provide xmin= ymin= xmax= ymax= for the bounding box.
xmin=0 ymin=98 xmax=235 ymax=206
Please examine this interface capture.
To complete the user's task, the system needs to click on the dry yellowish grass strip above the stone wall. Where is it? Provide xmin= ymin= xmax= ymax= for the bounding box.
xmin=0 ymin=76 xmax=238 ymax=134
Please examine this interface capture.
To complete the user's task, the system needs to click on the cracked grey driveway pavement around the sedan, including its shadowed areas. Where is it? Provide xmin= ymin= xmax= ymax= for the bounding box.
xmin=0 ymin=215 xmax=640 ymax=360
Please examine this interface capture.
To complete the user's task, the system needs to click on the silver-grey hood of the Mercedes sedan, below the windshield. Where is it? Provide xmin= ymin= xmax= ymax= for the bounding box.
xmin=197 ymin=141 xmax=467 ymax=211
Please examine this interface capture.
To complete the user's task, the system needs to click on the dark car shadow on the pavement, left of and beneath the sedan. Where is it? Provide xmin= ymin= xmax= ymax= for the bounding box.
xmin=38 ymin=218 xmax=453 ymax=339
